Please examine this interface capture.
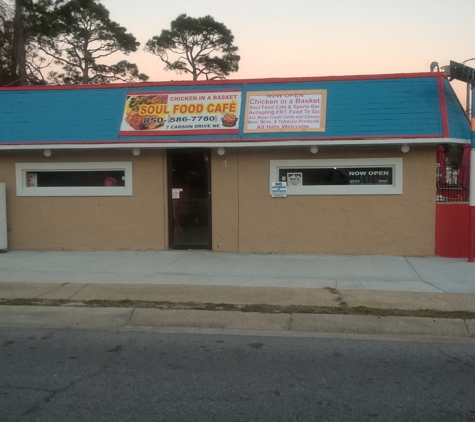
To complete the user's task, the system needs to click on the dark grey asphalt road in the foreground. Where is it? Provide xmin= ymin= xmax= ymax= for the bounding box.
xmin=0 ymin=328 xmax=475 ymax=422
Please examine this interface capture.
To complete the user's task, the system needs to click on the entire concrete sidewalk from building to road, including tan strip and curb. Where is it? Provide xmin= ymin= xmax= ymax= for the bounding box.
xmin=0 ymin=251 xmax=475 ymax=341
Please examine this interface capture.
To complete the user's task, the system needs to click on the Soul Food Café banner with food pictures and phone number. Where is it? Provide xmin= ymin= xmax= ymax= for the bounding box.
xmin=121 ymin=91 xmax=241 ymax=135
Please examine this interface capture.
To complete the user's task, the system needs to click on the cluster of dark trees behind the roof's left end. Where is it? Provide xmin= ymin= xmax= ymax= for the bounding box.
xmin=0 ymin=0 xmax=148 ymax=86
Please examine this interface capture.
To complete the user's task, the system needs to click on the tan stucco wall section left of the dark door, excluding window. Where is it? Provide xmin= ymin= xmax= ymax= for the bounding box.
xmin=0 ymin=151 xmax=166 ymax=250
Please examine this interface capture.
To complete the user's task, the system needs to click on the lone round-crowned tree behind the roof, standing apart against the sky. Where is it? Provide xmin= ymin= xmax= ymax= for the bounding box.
xmin=145 ymin=14 xmax=240 ymax=81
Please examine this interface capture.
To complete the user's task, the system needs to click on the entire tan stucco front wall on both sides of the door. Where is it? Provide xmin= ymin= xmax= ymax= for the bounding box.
xmin=0 ymin=147 xmax=436 ymax=256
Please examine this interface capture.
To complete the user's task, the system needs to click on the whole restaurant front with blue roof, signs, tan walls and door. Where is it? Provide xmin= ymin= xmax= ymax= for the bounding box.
xmin=0 ymin=73 xmax=470 ymax=256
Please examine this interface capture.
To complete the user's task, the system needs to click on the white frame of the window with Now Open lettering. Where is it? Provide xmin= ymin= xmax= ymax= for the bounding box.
xmin=269 ymin=157 xmax=403 ymax=196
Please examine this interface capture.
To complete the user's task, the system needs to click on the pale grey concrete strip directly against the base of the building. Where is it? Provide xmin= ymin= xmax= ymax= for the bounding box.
xmin=0 ymin=251 xmax=475 ymax=293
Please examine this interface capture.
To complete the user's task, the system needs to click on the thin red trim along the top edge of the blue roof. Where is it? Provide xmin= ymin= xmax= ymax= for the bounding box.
xmin=0 ymin=72 xmax=443 ymax=91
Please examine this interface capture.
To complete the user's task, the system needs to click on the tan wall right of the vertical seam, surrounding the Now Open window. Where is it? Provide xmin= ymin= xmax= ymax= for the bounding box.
xmin=239 ymin=147 xmax=436 ymax=256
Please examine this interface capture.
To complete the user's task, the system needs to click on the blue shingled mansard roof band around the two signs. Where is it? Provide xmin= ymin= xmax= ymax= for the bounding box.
xmin=0 ymin=76 xmax=470 ymax=144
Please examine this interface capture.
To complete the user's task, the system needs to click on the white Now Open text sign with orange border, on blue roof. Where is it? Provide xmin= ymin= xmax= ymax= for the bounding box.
xmin=244 ymin=89 xmax=327 ymax=133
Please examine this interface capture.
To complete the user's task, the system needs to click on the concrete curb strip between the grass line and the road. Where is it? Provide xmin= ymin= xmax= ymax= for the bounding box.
xmin=0 ymin=306 xmax=475 ymax=339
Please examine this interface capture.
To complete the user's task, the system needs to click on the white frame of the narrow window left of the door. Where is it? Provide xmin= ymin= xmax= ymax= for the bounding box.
xmin=15 ymin=162 xmax=133 ymax=196
